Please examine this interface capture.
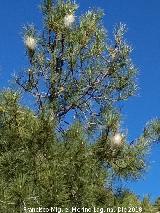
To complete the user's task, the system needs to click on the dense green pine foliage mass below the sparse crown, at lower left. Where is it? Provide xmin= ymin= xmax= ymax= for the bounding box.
xmin=0 ymin=92 xmax=112 ymax=212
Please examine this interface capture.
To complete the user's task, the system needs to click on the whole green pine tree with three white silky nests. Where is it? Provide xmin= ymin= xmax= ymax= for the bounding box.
xmin=0 ymin=0 xmax=160 ymax=212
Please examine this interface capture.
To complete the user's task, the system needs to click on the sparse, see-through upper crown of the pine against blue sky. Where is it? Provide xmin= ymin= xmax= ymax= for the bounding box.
xmin=16 ymin=1 xmax=137 ymax=131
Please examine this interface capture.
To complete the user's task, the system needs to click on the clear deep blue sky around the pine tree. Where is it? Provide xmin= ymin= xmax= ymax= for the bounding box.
xmin=0 ymin=0 xmax=160 ymax=202
